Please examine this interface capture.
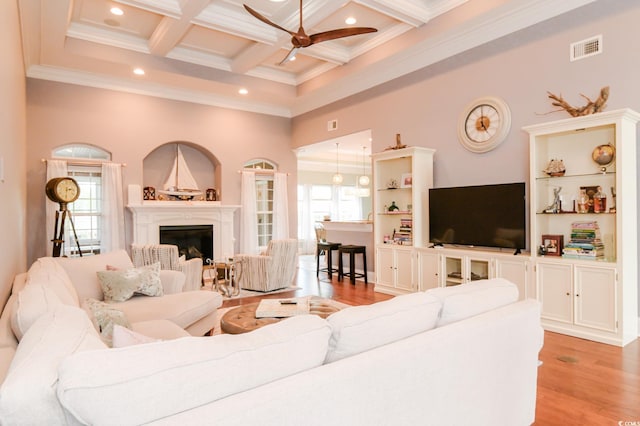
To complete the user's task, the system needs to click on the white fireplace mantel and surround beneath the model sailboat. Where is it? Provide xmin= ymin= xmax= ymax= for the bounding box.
xmin=127 ymin=201 xmax=240 ymax=259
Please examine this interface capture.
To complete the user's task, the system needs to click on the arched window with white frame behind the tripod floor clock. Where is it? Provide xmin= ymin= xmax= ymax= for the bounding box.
xmin=51 ymin=143 xmax=111 ymax=257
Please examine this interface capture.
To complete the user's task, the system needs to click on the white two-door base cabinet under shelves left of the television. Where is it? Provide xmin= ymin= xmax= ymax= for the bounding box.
xmin=376 ymin=245 xmax=418 ymax=294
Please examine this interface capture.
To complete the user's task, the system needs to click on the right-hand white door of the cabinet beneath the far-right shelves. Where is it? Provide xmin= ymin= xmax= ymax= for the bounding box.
xmin=575 ymin=266 xmax=616 ymax=331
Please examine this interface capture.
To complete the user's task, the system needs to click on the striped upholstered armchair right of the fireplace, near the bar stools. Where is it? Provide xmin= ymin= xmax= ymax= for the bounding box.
xmin=234 ymin=239 xmax=298 ymax=292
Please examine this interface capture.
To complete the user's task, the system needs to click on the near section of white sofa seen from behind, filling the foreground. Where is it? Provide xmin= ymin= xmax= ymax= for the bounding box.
xmin=0 ymin=272 xmax=543 ymax=426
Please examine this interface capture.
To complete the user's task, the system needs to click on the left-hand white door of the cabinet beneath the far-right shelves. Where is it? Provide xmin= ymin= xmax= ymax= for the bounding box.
xmin=536 ymin=262 xmax=573 ymax=323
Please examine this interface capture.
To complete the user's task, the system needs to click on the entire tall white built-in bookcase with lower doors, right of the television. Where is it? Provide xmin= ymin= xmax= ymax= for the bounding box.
xmin=525 ymin=109 xmax=640 ymax=346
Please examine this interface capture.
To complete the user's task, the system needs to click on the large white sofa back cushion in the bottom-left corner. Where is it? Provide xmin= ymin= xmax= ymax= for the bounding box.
xmin=0 ymin=304 xmax=106 ymax=425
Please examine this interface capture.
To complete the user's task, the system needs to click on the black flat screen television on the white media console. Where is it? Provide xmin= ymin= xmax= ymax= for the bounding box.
xmin=429 ymin=182 xmax=526 ymax=252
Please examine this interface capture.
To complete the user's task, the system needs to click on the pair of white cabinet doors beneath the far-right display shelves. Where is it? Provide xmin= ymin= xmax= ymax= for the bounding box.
xmin=536 ymin=261 xmax=617 ymax=337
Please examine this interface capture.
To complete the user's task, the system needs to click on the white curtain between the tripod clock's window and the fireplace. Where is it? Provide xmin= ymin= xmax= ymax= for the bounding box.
xmin=100 ymin=163 xmax=125 ymax=253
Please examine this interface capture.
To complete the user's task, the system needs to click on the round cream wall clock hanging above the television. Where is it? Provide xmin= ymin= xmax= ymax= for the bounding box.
xmin=458 ymin=96 xmax=511 ymax=153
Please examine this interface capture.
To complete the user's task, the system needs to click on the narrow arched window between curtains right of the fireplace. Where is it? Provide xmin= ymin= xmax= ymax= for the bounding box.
xmin=244 ymin=158 xmax=277 ymax=248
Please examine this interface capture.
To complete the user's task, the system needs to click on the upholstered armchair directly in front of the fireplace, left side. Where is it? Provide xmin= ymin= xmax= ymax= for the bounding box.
xmin=131 ymin=244 xmax=202 ymax=291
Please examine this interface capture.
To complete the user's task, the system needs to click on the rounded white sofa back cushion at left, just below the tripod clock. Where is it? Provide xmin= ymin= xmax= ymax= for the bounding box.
xmin=26 ymin=257 xmax=80 ymax=306
